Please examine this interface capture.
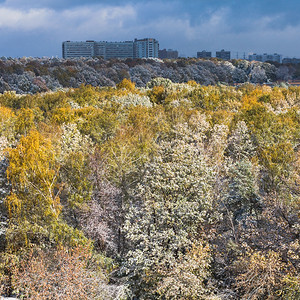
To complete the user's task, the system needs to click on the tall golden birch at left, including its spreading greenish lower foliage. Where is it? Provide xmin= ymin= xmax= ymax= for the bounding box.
xmin=6 ymin=130 xmax=85 ymax=250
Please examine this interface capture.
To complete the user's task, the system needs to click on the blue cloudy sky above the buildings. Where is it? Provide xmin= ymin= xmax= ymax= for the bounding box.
xmin=0 ymin=0 xmax=300 ymax=58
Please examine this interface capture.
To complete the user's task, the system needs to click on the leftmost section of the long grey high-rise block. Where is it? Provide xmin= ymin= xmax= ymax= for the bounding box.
xmin=62 ymin=41 xmax=95 ymax=58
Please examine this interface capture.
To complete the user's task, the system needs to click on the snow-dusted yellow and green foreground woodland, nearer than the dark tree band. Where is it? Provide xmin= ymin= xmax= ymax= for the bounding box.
xmin=0 ymin=76 xmax=300 ymax=300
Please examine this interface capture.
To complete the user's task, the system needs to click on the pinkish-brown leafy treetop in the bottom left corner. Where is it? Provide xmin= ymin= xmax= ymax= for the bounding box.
xmin=13 ymin=248 xmax=105 ymax=300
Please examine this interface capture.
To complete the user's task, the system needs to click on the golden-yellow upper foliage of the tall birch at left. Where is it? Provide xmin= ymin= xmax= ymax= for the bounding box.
xmin=6 ymin=130 xmax=61 ymax=250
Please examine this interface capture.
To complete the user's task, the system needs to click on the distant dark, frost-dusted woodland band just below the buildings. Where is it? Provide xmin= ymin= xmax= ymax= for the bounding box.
xmin=0 ymin=57 xmax=300 ymax=94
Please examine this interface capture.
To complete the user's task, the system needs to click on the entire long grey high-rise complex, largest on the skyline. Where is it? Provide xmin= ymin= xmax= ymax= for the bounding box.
xmin=62 ymin=38 xmax=159 ymax=59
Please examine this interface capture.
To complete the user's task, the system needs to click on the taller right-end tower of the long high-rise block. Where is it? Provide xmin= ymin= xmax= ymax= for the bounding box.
xmin=133 ymin=38 xmax=159 ymax=58
